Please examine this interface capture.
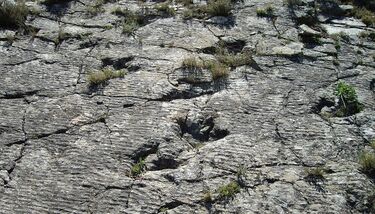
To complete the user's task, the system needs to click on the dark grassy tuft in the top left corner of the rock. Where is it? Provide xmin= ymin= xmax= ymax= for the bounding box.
xmin=0 ymin=1 xmax=29 ymax=28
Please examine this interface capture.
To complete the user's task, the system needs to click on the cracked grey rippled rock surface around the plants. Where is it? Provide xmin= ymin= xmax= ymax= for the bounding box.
xmin=0 ymin=0 xmax=375 ymax=214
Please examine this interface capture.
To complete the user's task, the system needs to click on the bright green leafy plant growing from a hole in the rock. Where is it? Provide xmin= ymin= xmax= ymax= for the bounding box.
xmin=336 ymin=82 xmax=363 ymax=117
